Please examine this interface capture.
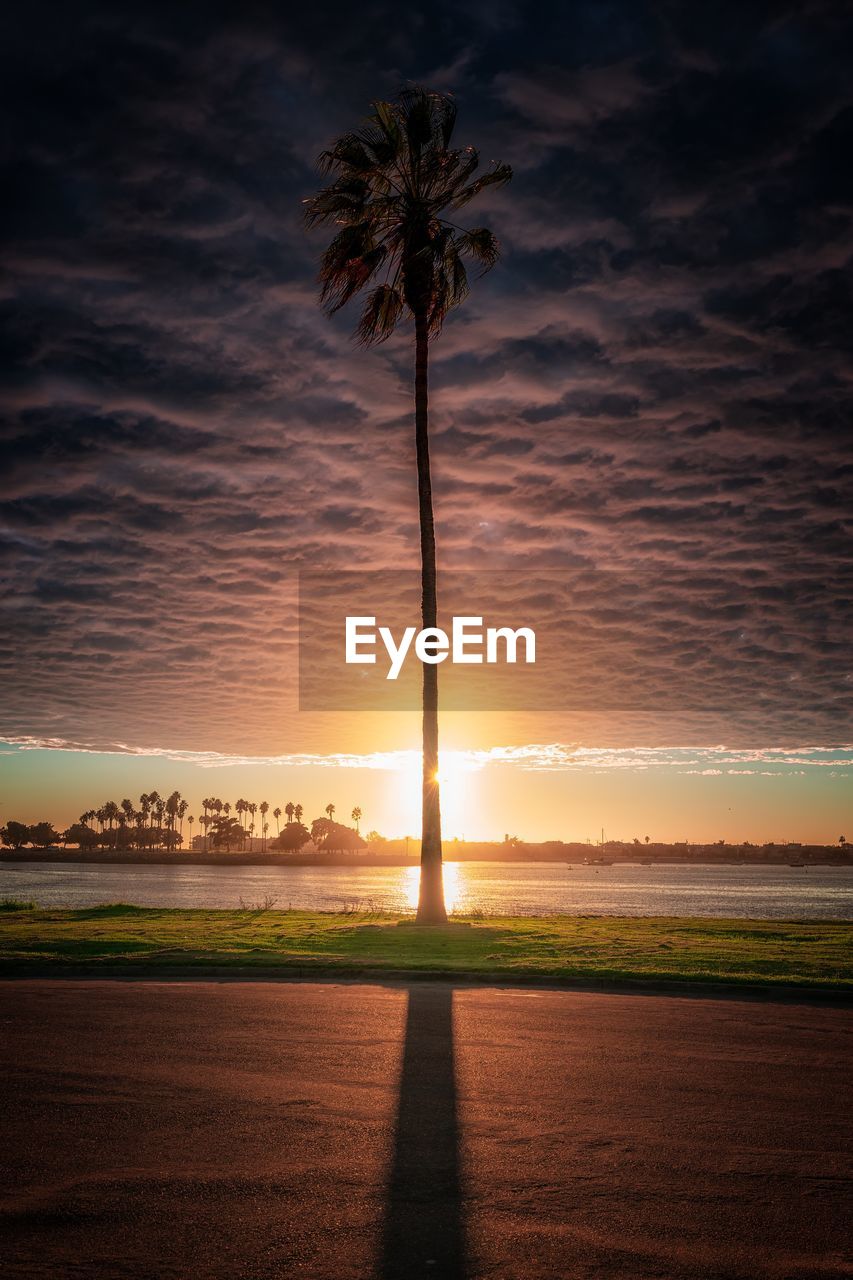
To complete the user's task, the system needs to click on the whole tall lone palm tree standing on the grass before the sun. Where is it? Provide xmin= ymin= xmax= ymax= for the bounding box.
xmin=305 ymin=87 xmax=512 ymax=924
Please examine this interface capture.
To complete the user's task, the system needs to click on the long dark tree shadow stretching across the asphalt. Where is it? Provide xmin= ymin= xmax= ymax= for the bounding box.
xmin=379 ymin=984 xmax=466 ymax=1280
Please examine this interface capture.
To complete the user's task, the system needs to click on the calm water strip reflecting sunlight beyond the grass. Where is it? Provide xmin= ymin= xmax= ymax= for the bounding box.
xmin=0 ymin=861 xmax=853 ymax=920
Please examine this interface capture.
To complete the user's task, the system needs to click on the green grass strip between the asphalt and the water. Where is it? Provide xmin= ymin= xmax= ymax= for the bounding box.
xmin=0 ymin=900 xmax=853 ymax=991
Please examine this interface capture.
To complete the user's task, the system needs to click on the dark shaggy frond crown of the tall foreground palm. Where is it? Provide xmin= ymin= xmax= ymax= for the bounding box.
xmin=305 ymin=87 xmax=512 ymax=344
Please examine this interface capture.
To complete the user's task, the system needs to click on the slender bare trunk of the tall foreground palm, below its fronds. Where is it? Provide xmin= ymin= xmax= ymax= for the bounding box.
xmin=415 ymin=314 xmax=447 ymax=924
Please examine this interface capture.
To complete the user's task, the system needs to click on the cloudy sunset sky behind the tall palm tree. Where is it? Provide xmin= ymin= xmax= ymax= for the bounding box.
xmin=0 ymin=0 xmax=853 ymax=841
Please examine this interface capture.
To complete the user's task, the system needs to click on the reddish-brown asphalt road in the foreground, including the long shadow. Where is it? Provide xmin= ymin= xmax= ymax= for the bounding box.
xmin=0 ymin=980 xmax=853 ymax=1280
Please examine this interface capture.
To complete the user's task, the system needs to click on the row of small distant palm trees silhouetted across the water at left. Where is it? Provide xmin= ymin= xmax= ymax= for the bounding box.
xmin=72 ymin=791 xmax=361 ymax=851
